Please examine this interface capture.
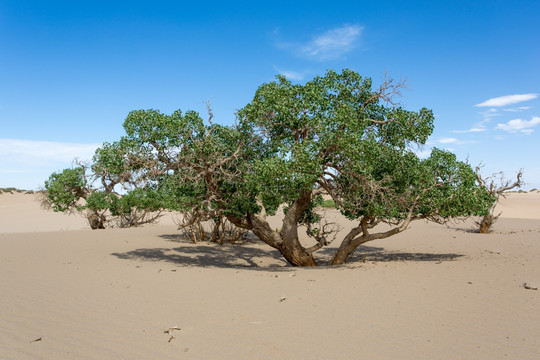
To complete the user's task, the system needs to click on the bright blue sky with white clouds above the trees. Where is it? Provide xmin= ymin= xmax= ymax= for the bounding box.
xmin=0 ymin=0 xmax=540 ymax=189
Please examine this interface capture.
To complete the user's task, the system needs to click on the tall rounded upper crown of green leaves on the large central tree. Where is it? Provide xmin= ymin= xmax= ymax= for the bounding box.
xmin=238 ymin=70 xmax=433 ymax=217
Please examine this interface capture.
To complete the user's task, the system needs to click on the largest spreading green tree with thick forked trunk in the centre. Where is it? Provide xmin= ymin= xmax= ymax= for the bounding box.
xmin=117 ymin=70 xmax=493 ymax=266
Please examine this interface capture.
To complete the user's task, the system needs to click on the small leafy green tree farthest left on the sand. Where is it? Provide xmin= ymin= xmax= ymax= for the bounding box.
xmin=42 ymin=141 xmax=163 ymax=229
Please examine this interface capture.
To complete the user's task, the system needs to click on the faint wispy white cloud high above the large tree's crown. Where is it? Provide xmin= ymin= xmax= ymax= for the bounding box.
xmin=274 ymin=25 xmax=364 ymax=61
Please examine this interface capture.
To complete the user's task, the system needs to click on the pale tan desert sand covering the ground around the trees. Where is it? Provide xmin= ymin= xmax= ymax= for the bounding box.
xmin=0 ymin=193 xmax=540 ymax=359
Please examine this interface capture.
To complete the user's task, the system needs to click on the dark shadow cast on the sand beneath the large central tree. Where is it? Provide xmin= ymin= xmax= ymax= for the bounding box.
xmin=112 ymin=234 xmax=463 ymax=270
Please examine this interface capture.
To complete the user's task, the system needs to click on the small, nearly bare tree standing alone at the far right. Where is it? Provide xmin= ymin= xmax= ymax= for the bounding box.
xmin=475 ymin=166 xmax=523 ymax=234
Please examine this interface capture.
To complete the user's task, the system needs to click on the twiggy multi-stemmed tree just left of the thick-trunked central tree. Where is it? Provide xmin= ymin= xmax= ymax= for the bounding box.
xmin=118 ymin=107 xmax=249 ymax=243
